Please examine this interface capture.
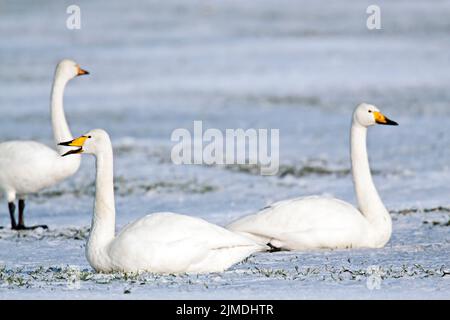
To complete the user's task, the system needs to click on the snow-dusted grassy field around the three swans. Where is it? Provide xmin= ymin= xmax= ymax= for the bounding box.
xmin=0 ymin=0 xmax=450 ymax=299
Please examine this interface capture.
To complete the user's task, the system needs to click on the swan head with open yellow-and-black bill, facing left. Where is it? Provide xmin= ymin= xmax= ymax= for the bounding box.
xmin=59 ymin=129 xmax=111 ymax=157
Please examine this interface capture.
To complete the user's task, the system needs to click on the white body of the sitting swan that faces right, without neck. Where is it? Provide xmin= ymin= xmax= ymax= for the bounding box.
xmin=227 ymin=196 xmax=390 ymax=250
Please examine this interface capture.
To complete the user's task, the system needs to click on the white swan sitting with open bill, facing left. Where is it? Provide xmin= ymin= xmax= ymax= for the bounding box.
xmin=57 ymin=129 xmax=267 ymax=273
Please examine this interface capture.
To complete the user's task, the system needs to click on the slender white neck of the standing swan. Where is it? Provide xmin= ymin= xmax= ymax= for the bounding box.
xmin=50 ymin=71 xmax=74 ymax=154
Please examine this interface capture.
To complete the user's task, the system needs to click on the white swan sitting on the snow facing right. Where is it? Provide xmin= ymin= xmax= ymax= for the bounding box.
xmin=227 ymin=103 xmax=397 ymax=250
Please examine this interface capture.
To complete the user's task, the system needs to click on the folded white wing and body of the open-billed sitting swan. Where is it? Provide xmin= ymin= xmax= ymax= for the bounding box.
xmin=110 ymin=213 xmax=265 ymax=273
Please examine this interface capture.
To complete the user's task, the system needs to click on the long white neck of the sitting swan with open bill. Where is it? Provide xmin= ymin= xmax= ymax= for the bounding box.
xmin=86 ymin=141 xmax=116 ymax=271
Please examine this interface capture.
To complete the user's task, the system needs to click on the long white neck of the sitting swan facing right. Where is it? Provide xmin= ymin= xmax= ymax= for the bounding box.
xmin=350 ymin=120 xmax=392 ymax=245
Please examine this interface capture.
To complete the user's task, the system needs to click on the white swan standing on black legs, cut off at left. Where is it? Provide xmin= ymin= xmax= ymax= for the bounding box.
xmin=0 ymin=60 xmax=89 ymax=230
